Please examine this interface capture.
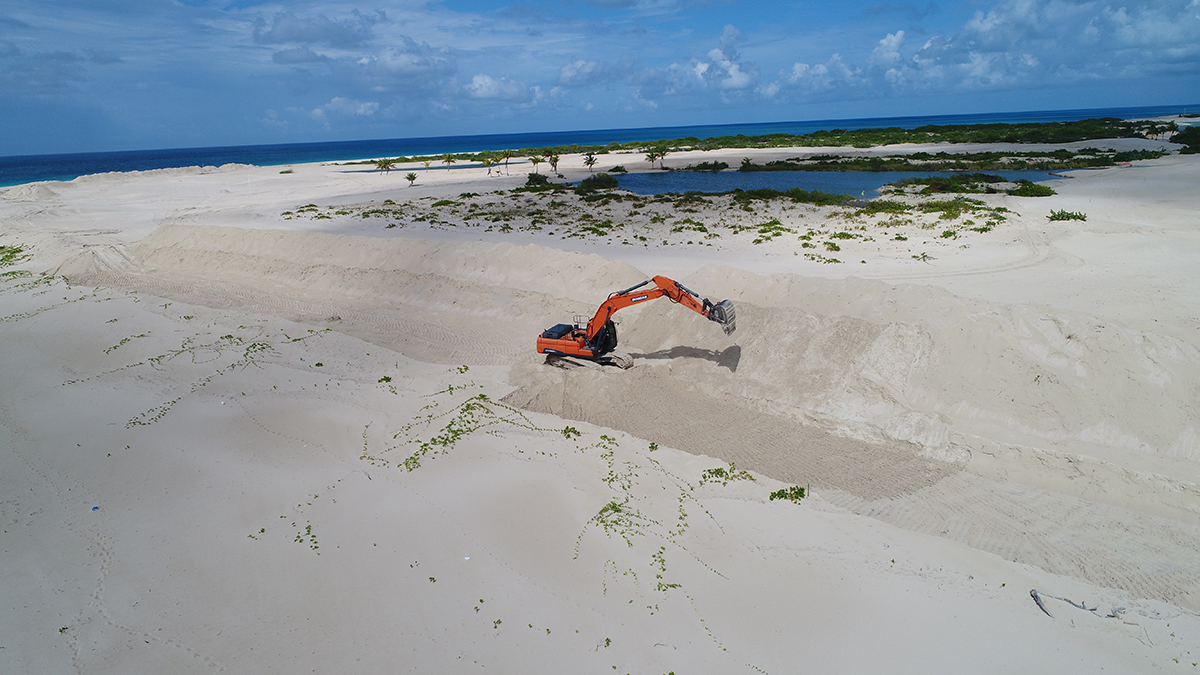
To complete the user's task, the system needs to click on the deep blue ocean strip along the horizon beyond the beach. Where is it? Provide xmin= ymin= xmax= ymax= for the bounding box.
xmin=0 ymin=104 xmax=1200 ymax=187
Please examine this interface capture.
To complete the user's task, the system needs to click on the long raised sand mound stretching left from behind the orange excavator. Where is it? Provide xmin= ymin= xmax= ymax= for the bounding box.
xmin=58 ymin=226 xmax=642 ymax=364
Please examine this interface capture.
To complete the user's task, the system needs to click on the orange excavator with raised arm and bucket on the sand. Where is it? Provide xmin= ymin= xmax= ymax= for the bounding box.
xmin=538 ymin=276 xmax=737 ymax=368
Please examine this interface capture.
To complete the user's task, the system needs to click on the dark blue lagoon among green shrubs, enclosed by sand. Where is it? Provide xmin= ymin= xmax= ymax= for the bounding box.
xmin=617 ymin=171 xmax=1060 ymax=197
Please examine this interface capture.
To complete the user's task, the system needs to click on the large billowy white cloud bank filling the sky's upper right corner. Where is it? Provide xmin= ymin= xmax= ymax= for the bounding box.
xmin=758 ymin=0 xmax=1200 ymax=98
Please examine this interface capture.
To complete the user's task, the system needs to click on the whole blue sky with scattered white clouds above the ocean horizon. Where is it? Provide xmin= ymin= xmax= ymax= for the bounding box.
xmin=0 ymin=0 xmax=1200 ymax=155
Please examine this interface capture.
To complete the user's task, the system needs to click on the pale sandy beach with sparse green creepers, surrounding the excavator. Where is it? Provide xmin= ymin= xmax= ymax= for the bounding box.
xmin=0 ymin=139 xmax=1200 ymax=675
